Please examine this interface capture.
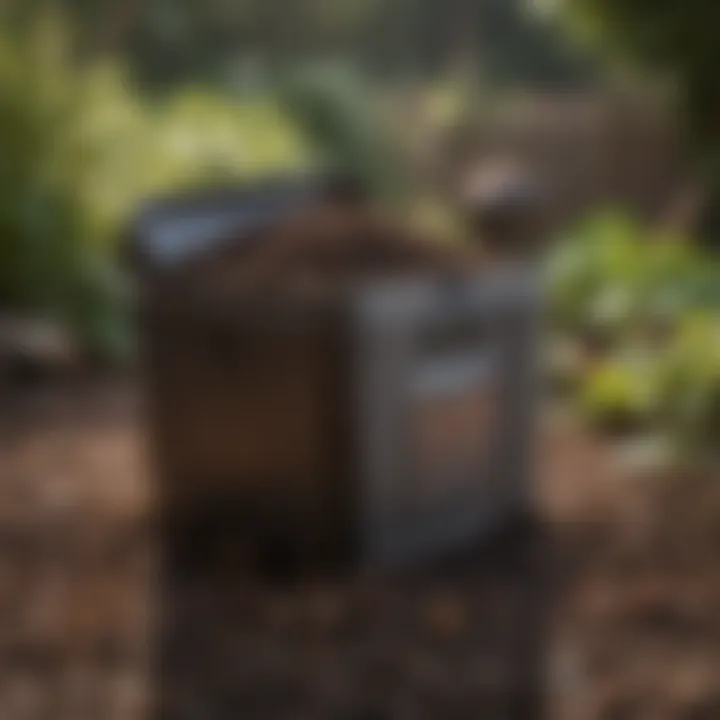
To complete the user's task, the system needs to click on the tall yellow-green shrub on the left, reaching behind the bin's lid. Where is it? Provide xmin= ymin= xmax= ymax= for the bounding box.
xmin=0 ymin=11 xmax=309 ymax=356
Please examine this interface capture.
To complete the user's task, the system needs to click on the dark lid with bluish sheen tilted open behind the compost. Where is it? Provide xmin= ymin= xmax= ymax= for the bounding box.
xmin=126 ymin=173 xmax=360 ymax=273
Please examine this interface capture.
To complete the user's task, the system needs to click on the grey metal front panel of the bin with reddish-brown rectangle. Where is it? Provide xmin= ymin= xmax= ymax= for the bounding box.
xmin=354 ymin=272 xmax=538 ymax=565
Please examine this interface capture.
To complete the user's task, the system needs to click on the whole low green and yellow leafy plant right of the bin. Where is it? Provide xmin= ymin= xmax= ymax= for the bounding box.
xmin=547 ymin=213 xmax=720 ymax=456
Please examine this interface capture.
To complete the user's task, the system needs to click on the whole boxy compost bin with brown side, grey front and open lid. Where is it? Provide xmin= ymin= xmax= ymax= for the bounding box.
xmin=134 ymin=181 xmax=539 ymax=568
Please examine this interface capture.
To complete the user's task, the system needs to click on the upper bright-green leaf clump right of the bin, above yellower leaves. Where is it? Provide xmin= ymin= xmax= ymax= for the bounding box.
xmin=548 ymin=212 xmax=720 ymax=344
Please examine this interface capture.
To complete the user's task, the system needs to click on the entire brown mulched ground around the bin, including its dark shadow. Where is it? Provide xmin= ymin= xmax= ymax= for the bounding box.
xmin=0 ymin=381 xmax=720 ymax=720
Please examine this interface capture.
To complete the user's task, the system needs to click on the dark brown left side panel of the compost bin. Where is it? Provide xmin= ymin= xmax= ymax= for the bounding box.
xmin=144 ymin=312 xmax=343 ymax=564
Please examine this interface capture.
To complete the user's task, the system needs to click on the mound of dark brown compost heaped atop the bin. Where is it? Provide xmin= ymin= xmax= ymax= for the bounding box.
xmin=192 ymin=206 xmax=479 ymax=303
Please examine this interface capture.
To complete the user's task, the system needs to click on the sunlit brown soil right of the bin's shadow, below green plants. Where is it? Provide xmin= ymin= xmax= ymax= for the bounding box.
xmin=543 ymin=422 xmax=720 ymax=720
